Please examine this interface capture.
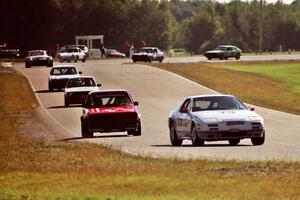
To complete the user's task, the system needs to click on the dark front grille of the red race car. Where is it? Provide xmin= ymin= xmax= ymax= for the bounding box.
xmin=89 ymin=112 xmax=138 ymax=130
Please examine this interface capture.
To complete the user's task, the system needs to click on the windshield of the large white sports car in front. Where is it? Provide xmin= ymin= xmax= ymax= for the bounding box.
xmin=192 ymin=96 xmax=247 ymax=112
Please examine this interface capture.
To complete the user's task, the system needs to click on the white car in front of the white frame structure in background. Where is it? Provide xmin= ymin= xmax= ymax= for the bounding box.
xmin=57 ymin=47 xmax=86 ymax=62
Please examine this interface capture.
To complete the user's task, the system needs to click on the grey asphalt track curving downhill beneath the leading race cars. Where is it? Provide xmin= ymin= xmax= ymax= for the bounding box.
xmin=17 ymin=57 xmax=300 ymax=160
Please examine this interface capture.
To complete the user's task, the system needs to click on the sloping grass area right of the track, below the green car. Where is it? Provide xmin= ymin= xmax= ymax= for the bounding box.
xmin=151 ymin=61 xmax=300 ymax=115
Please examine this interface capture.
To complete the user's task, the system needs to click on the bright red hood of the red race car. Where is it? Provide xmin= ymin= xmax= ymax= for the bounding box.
xmin=88 ymin=104 xmax=136 ymax=115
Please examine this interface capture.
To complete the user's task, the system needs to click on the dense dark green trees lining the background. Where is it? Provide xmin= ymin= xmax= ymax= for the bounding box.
xmin=0 ymin=0 xmax=300 ymax=53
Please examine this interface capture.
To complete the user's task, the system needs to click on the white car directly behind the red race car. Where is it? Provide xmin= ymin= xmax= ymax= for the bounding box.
xmin=64 ymin=76 xmax=101 ymax=106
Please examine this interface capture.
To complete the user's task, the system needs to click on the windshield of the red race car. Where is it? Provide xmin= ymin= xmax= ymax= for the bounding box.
xmin=87 ymin=92 xmax=132 ymax=107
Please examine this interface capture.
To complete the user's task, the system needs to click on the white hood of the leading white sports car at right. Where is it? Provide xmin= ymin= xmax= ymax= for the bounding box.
xmin=193 ymin=110 xmax=263 ymax=123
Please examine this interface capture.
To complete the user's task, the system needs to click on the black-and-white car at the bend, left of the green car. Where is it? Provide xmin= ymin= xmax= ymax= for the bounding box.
xmin=131 ymin=47 xmax=164 ymax=62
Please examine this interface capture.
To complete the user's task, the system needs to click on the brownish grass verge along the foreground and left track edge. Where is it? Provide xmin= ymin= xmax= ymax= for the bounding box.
xmin=0 ymin=67 xmax=300 ymax=200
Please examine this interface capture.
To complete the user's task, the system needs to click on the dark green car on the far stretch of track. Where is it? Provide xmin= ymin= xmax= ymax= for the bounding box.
xmin=204 ymin=45 xmax=242 ymax=60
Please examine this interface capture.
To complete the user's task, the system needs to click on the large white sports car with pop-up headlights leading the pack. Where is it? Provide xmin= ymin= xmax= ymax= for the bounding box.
xmin=168 ymin=95 xmax=265 ymax=146
